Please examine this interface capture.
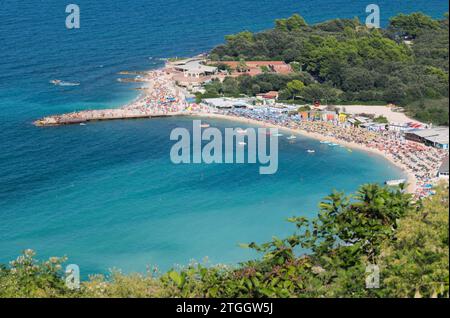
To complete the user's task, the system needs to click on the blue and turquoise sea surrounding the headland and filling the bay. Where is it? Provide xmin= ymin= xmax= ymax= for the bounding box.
xmin=0 ymin=0 xmax=448 ymax=276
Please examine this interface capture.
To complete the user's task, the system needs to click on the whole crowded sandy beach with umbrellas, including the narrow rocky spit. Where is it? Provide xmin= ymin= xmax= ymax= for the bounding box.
xmin=34 ymin=60 xmax=448 ymax=198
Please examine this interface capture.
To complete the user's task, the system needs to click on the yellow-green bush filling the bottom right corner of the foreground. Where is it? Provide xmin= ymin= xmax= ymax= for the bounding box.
xmin=379 ymin=184 xmax=449 ymax=298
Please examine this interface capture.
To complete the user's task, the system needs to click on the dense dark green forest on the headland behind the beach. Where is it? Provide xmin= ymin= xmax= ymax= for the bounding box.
xmin=199 ymin=13 xmax=449 ymax=125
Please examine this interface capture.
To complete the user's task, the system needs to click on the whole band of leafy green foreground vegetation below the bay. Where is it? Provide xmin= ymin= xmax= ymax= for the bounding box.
xmin=0 ymin=184 xmax=449 ymax=298
